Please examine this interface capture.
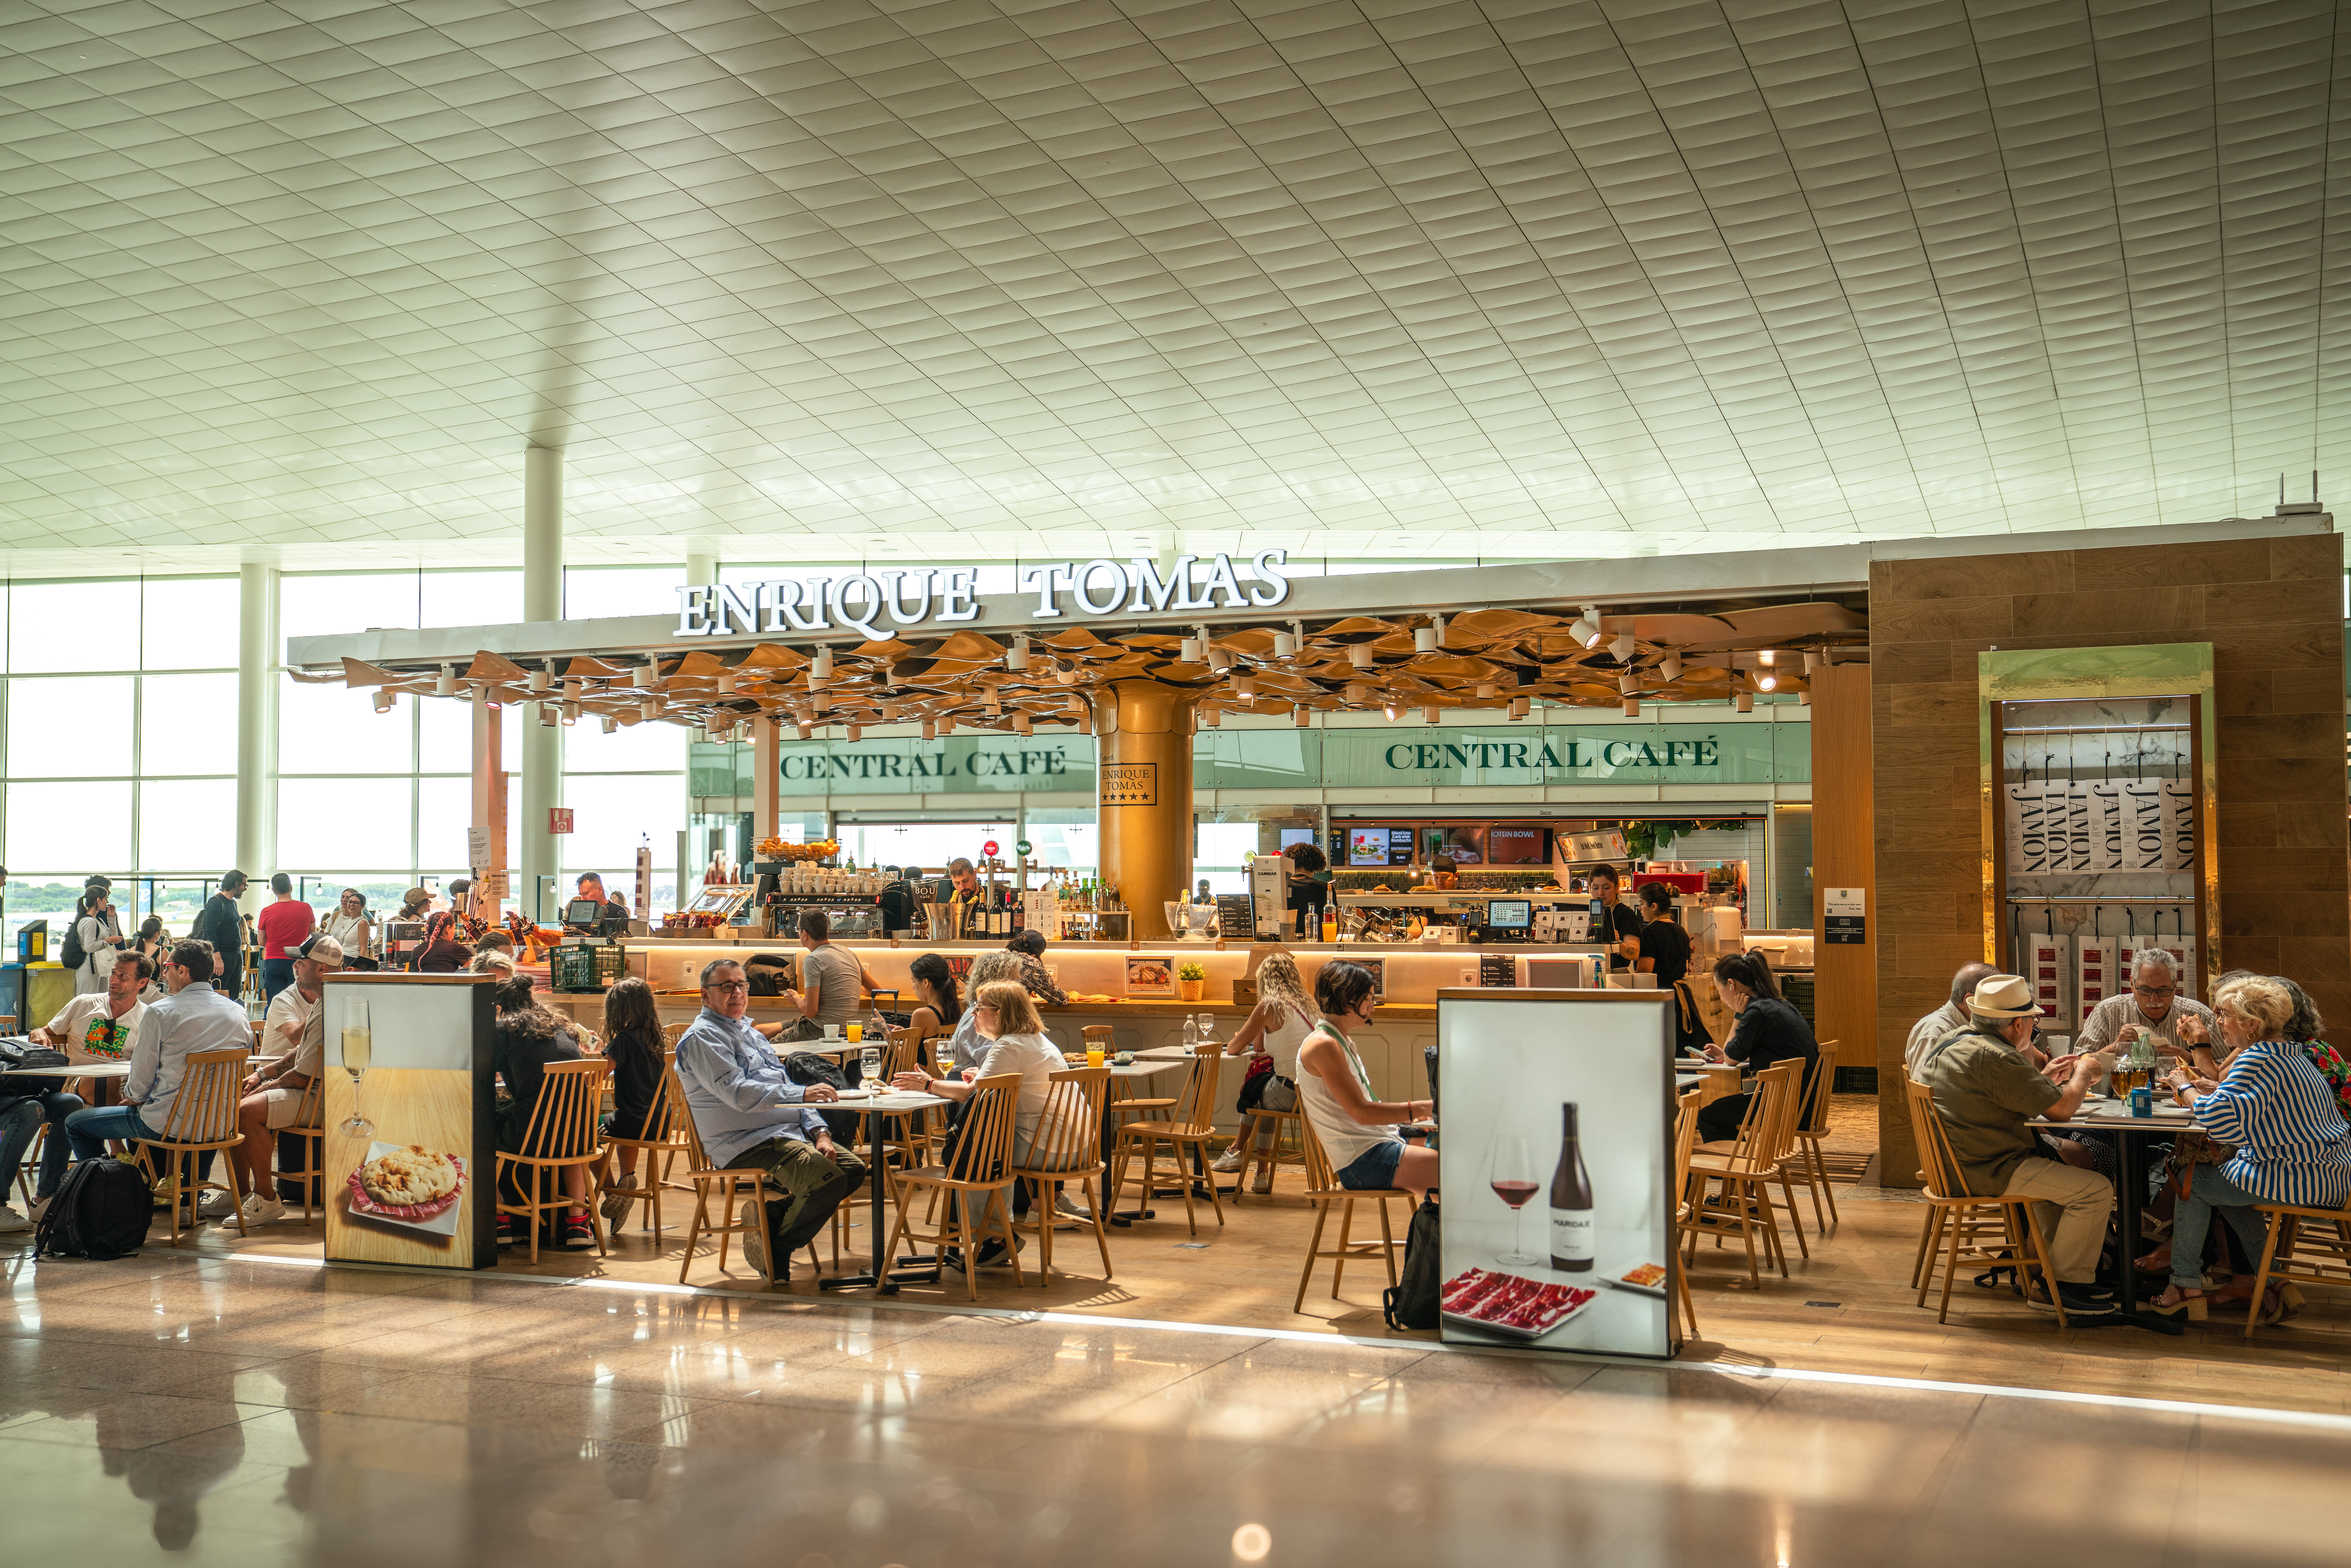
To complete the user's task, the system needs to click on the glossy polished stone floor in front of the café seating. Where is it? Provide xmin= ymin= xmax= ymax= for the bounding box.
xmin=0 ymin=1251 xmax=2351 ymax=1568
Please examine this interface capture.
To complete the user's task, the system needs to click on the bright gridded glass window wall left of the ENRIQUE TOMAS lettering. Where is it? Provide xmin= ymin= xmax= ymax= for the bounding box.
xmin=0 ymin=566 xmax=686 ymax=955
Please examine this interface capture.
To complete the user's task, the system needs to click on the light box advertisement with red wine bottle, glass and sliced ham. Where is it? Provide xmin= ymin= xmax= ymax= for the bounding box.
xmin=1436 ymin=990 xmax=1679 ymax=1356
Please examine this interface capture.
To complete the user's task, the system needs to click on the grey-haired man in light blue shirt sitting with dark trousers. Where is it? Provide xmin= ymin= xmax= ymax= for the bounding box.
xmin=677 ymin=959 xmax=865 ymax=1284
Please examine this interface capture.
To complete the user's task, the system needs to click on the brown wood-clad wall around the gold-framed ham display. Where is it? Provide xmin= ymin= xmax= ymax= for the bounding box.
xmin=1862 ymin=524 xmax=2351 ymax=1185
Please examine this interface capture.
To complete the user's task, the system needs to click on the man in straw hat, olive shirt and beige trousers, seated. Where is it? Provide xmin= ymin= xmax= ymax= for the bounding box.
xmin=1916 ymin=976 xmax=2114 ymax=1314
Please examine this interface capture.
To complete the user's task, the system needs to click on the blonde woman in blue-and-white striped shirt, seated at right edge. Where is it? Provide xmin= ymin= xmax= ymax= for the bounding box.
xmin=2151 ymin=976 xmax=2351 ymax=1324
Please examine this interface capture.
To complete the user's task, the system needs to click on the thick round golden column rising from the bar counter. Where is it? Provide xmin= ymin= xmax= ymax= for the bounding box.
xmin=1093 ymin=682 xmax=1194 ymax=940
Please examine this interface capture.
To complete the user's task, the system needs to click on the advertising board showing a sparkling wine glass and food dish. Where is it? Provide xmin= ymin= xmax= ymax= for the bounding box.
xmin=320 ymin=971 xmax=499 ymax=1269
